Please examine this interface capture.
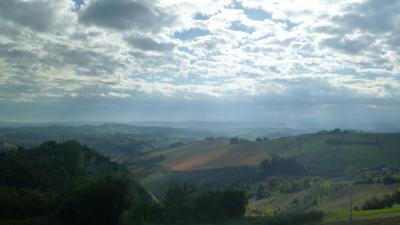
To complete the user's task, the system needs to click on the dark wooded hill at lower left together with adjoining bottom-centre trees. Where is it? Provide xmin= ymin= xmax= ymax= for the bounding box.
xmin=0 ymin=141 xmax=253 ymax=225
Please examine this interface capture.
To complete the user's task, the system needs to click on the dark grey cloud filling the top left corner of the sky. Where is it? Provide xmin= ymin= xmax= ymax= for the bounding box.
xmin=0 ymin=0 xmax=61 ymax=31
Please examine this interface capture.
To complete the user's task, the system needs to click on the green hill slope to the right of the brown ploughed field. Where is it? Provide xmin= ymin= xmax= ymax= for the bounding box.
xmin=259 ymin=133 xmax=400 ymax=171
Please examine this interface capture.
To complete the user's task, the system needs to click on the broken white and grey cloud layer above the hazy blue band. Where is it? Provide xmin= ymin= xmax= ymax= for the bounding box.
xmin=0 ymin=0 xmax=400 ymax=118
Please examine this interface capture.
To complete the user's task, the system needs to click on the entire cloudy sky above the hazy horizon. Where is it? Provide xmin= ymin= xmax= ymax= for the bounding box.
xmin=0 ymin=0 xmax=400 ymax=126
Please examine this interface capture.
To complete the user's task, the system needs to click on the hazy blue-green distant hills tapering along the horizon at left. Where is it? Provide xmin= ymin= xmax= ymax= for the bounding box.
xmin=0 ymin=124 xmax=212 ymax=157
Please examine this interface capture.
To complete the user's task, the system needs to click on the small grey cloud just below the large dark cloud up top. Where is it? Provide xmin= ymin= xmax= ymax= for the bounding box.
xmin=125 ymin=37 xmax=174 ymax=52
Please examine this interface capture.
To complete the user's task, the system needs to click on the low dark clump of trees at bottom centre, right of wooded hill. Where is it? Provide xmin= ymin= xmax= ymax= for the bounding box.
xmin=132 ymin=183 xmax=247 ymax=225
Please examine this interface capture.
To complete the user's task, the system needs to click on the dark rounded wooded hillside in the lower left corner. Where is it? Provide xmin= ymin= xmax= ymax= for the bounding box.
xmin=0 ymin=141 xmax=153 ymax=225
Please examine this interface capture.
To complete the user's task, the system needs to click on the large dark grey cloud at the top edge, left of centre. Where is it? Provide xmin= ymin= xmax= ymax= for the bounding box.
xmin=79 ymin=0 xmax=174 ymax=32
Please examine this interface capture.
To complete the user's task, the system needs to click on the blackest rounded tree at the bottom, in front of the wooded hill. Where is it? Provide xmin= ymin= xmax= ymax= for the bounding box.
xmin=58 ymin=176 xmax=132 ymax=225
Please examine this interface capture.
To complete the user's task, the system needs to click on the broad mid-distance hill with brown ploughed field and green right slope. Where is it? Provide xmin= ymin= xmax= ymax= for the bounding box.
xmin=130 ymin=131 xmax=400 ymax=174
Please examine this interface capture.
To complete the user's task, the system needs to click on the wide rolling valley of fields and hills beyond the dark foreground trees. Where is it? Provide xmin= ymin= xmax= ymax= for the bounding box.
xmin=0 ymin=124 xmax=400 ymax=224
